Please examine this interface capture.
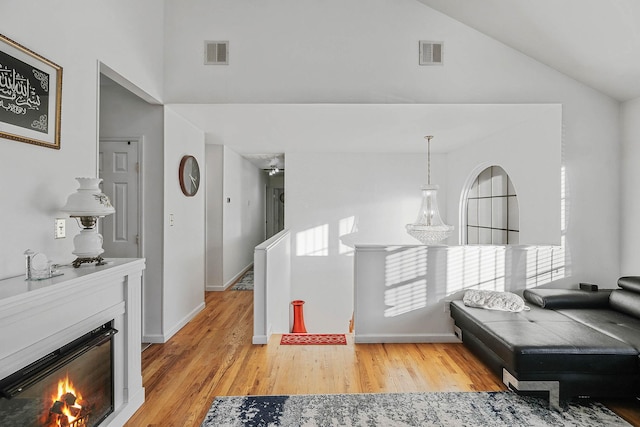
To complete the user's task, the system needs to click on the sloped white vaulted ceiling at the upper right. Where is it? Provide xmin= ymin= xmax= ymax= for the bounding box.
xmin=418 ymin=0 xmax=640 ymax=101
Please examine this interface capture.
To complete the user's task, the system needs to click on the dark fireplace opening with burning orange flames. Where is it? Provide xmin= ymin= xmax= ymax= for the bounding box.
xmin=0 ymin=322 xmax=118 ymax=427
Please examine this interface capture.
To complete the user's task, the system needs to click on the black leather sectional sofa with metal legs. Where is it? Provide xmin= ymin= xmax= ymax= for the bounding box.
xmin=451 ymin=277 xmax=640 ymax=409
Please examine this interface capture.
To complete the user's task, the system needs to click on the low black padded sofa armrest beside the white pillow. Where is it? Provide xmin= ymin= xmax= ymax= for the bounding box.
xmin=523 ymin=289 xmax=611 ymax=309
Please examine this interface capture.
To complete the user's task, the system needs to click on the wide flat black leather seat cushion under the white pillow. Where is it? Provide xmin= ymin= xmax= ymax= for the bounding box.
xmin=451 ymin=300 xmax=638 ymax=375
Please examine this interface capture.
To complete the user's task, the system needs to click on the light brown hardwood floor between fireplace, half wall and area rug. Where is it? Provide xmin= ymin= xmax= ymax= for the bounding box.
xmin=126 ymin=290 xmax=640 ymax=427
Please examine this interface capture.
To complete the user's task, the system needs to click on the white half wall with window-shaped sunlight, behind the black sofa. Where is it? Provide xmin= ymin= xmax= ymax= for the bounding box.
xmin=354 ymin=245 xmax=572 ymax=343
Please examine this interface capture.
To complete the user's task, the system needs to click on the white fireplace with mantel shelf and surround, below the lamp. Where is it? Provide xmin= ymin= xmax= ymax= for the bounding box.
xmin=0 ymin=258 xmax=144 ymax=427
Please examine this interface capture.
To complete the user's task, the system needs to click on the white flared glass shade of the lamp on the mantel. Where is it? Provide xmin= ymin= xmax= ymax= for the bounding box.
xmin=62 ymin=178 xmax=115 ymax=217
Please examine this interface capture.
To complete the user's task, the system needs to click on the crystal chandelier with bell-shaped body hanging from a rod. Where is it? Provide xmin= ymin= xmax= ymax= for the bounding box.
xmin=406 ymin=135 xmax=453 ymax=245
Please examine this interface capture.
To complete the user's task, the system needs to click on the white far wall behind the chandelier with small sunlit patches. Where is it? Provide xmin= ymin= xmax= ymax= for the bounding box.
xmin=285 ymin=153 xmax=448 ymax=333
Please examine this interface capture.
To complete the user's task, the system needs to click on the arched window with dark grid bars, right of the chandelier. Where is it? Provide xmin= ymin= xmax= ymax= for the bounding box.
xmin=466 ymin=166 xmax=520 ymax=245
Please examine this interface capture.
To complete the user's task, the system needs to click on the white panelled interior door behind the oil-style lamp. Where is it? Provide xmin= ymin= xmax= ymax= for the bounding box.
xmin=99 ymin=140 xmax=141 ymax=258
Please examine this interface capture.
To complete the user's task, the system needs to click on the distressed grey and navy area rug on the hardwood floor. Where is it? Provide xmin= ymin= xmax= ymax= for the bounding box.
xmin=201 ymin=392 xmax=630 ymax=427
